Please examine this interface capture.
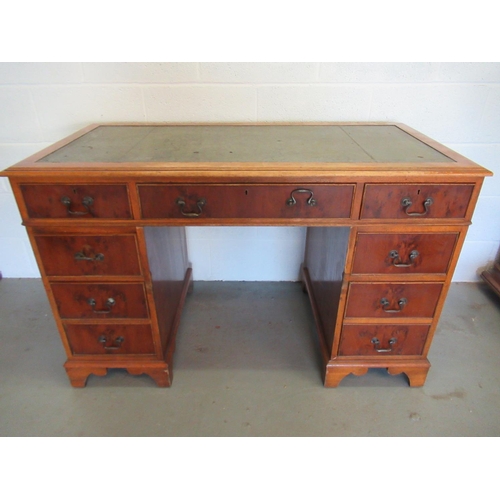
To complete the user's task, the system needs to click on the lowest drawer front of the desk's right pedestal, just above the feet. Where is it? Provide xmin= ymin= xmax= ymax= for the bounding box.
xmin=339 ymin=325 xmax=429 ymax=356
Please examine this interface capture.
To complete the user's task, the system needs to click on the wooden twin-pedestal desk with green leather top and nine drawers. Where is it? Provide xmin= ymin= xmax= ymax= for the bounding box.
xmin=3 ymin=123 xmax=491 ymax=387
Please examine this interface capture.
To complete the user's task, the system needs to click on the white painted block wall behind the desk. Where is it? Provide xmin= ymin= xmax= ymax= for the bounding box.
xmin=0 ymin=63 xmax=500 ymax=281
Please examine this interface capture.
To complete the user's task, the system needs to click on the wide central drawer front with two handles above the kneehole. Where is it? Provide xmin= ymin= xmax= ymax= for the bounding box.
xmin=138 ymin=184 xmax=354 ymax=219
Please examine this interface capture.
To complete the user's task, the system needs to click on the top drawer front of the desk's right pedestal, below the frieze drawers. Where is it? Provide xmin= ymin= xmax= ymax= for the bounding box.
xmin=352 ymin=233 xmax=458 ymax=274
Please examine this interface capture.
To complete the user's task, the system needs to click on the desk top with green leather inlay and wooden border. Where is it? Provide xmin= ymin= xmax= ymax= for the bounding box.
xmin=0 ymin=123 xmax=490 ymax=177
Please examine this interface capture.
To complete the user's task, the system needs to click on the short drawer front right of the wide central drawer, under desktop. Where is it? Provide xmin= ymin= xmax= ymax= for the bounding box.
xmin=361 ymin=184 xmax=474 ymax=220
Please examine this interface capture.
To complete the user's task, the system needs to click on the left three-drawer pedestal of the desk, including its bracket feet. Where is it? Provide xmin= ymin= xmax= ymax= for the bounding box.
xmin=28 ymin=226 xmax=192 ymax=387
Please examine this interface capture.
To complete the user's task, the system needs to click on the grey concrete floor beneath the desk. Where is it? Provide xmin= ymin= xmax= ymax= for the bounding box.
xmin=0 ymin=279 xmax=500 ymax=436
